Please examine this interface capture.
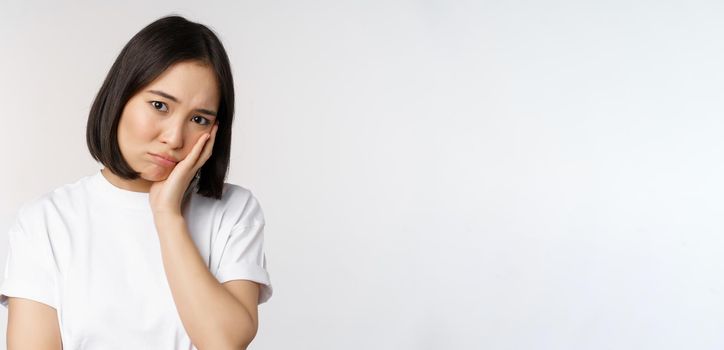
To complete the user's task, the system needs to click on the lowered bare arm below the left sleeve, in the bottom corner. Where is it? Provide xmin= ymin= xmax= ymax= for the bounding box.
xmin=6 ymin=297 xmax=63 ymax=350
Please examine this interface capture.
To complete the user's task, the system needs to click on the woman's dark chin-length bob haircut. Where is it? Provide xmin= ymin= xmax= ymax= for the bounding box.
xmin=86 ymin=15 xmax=234 ymax=199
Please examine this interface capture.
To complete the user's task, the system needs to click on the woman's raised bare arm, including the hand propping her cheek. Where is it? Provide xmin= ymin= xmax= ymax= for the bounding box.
xmin=149 ymin=120 xmax=259 ymax=350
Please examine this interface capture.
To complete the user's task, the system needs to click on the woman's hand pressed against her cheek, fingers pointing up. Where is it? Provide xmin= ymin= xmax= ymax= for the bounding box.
xmin=148 ymin=121 xmax=219 ymax=217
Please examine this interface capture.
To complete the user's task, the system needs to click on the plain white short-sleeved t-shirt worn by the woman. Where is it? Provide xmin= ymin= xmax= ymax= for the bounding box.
xmin=0 ymin=170 xmax=272 ymax=350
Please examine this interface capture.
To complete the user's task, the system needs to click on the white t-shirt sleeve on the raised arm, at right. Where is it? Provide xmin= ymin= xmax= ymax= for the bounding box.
xmin=215 ymin=195 xmax=273 ymax=304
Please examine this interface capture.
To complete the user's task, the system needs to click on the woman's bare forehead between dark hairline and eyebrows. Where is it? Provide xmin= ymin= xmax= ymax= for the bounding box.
xmin=143 ymin=61 xmax=220 ymax=109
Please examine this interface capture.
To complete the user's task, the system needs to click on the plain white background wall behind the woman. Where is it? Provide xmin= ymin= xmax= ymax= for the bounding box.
xmin=0 ymin=0 xmax=724 ymax=350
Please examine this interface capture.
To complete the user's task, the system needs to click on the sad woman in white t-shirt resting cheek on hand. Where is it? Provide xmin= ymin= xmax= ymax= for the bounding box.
xmin=0 ymin=16 xmax=272 ymax=350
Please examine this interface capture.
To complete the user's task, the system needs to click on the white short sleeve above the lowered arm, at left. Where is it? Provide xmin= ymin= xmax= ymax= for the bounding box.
xmin=0 ymin=213 xmax=58 ymax=309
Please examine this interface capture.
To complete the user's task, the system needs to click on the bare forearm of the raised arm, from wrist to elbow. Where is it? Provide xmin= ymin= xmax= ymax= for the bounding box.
xmin=155 ymin=215 xmax=254 ymax=350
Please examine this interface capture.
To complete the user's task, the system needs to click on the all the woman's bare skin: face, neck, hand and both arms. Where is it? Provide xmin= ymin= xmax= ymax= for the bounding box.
xmin=7 ymin=58 xmax=259 ymax=350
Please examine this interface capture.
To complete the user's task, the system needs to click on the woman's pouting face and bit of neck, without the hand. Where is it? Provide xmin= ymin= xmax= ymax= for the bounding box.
xmin=103 ymin=62 xmax=220 ymax=192
